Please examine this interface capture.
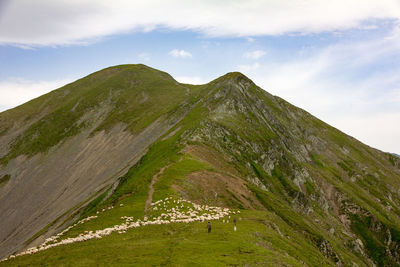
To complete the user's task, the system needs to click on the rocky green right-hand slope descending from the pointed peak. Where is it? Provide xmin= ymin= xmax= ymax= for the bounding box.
xmin=190 ymin=73 xmax=400 ymax=266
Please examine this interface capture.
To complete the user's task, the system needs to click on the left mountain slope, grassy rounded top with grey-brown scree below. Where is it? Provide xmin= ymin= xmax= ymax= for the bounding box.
xmin=0 ymin=65 xmax=205 ymax=256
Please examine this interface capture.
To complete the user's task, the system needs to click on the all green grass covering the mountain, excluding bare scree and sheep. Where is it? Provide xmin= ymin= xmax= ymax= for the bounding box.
xmin=0 ymin=65 xmax=400 ymax=266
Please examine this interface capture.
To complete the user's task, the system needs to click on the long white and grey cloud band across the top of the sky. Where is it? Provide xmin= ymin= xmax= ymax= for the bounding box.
xmin=0 ymin=0 xmax=400 ymax=46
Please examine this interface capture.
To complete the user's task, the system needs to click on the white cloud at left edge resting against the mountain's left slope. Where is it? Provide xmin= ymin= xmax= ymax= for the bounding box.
xmin=0 ymin=78 xmax=71 ymax=112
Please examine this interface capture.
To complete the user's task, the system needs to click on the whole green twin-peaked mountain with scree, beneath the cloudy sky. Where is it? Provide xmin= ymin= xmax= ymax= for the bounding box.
xmin=0 ymin=65 xmax=400 ymax=266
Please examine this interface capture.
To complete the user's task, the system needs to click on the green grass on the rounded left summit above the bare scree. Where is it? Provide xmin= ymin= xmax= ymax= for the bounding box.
xmin=0 ymin=65 xmax=202 ymax=165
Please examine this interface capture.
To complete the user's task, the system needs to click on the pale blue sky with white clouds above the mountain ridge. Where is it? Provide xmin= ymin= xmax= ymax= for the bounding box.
xmin=0 ymin=0 xmax=400 ymax=154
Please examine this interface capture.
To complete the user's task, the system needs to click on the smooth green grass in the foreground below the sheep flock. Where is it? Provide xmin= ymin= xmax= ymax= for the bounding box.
xmin=0 ymin=211 xmax=333 ymax=266
